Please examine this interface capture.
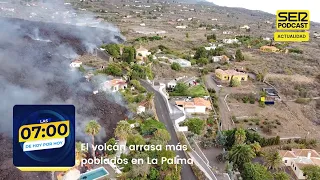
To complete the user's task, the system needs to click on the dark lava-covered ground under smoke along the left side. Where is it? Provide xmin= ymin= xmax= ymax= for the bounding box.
xmin=0 ymin=1 xmax=128 ymax=180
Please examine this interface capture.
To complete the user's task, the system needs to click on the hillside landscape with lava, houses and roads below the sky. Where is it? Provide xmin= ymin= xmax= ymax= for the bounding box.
xmin=0 ymin=0 xmax=320 ymax=180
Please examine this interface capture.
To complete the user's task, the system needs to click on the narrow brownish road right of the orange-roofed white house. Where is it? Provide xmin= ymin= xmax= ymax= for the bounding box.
xmin=204 ymin=74 xmax=233 ymax=130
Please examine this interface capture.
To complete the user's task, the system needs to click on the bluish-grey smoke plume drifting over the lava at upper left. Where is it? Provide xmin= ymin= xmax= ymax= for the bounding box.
xmin=0 ymin=0 xmax=126 ymax=140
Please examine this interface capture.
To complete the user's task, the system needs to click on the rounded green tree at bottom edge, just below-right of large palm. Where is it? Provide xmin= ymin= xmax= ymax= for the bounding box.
xmin=241 ymin=162 xmax=273 ymax=180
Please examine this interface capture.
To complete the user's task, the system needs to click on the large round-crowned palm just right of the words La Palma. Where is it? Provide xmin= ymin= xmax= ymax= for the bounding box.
xmin=228 ymin=144 xmax=256 ymax=168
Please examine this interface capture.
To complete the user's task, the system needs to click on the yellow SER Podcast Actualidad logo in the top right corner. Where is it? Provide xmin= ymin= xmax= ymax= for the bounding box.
xmin=274 ymin=10 xmax=310 ymax=42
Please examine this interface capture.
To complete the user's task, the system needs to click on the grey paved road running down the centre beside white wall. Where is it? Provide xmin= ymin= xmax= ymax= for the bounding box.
xmin=141 ymin=81 xmax=198 ymax=180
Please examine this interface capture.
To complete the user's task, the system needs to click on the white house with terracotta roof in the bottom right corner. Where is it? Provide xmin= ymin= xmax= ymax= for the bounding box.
xmin=279 ymin=149 xmax=320 ymax=179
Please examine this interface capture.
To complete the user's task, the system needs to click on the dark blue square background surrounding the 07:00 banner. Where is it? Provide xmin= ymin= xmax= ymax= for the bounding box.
xmin=13 ymin=105 xmax=75 ymax=168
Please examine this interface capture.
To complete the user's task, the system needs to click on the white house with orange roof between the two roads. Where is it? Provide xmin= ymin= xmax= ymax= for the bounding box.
xmin=175 ymin=98 xmax=212 ymax=114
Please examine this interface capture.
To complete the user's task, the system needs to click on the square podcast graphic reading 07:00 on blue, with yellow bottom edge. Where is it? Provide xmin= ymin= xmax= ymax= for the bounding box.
xmin=13 ymin=105 xmax=75 ymax=171
